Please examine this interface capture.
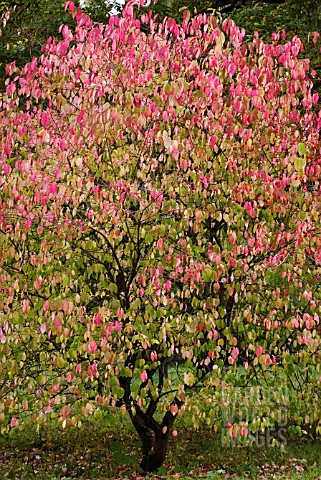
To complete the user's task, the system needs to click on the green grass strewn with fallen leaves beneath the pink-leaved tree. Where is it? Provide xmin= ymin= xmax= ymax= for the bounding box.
xmin=0 ymin=410 xmax=321 ymax=480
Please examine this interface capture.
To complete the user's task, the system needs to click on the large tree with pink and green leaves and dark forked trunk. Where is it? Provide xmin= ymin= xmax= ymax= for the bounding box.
xmin=0 ymin=0 xmax=321 ymax=471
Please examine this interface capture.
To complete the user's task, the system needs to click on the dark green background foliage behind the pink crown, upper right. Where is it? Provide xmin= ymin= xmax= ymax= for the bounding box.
xmin=139 ymin=0 xmax=321 ymax=93
